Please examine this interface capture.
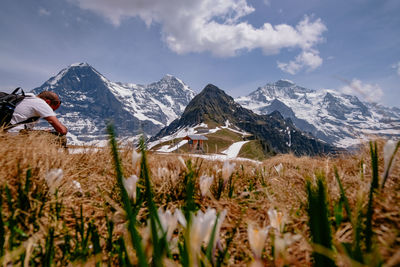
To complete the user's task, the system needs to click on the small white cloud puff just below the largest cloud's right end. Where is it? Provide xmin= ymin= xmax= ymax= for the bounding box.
xmin=278 ymin=49 xmax=323 ymax=75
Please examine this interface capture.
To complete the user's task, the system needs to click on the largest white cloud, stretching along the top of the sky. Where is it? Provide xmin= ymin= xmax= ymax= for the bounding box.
xmin=69 ymin=0 xmax=326 ymax=69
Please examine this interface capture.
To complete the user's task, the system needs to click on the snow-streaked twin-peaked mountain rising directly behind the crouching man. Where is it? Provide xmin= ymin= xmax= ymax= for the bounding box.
xmin=33 ymin=63 xmax=195 ymax=144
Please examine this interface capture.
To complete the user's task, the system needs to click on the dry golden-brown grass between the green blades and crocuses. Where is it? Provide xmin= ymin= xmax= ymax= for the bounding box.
xmin=0 ymin=135 xmax=400 ymax=266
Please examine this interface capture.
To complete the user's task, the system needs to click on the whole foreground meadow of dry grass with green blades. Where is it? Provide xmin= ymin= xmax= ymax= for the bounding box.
xmin=0 ymin=133 xmax=400 ymax=266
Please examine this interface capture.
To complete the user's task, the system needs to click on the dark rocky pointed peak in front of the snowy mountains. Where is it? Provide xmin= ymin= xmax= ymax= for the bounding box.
xmin=150 ymin=84 xmax=336 ymax=155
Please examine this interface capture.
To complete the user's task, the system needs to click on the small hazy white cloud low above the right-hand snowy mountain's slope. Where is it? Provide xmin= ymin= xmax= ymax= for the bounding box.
xmin=341 ymin=79 xmax=383 ymax=102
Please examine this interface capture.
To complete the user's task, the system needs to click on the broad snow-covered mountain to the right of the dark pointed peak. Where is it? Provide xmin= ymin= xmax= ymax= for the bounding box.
xmin=235 ymin=80 xmax=400 ymax=147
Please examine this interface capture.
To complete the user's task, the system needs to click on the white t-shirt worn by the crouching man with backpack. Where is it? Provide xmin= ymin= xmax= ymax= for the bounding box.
xmin=9 ymin=94 xmax=56 ymax=132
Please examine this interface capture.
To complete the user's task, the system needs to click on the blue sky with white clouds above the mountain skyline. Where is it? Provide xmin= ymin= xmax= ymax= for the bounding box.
xmin=0 ymin=0 xmax=400 ymax=107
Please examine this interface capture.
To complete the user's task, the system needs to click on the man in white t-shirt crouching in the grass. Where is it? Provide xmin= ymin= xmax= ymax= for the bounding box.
xmin=8 ymin=91 xmax=68 ymax=147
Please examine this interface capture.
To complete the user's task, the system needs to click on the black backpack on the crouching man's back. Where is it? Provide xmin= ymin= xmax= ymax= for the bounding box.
xmin=0 ymin=87 xmax=38 ymax=130
